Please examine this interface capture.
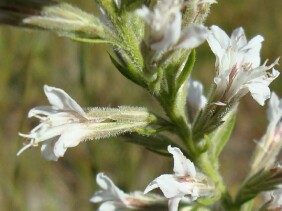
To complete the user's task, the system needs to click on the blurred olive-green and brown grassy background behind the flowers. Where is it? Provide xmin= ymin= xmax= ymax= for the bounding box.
xmin=0 ymin=0 xmax=282 ymax=211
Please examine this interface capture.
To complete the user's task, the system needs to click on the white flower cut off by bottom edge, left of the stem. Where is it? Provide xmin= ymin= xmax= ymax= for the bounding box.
xmin=90 ymin=173 xmax=164 ymax=211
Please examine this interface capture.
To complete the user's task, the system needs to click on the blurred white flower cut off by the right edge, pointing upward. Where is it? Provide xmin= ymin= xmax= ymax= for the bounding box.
xmin=251 ymin=92 xmax=282 ymax=174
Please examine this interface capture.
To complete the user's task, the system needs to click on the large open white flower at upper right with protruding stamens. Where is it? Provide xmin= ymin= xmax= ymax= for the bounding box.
xmin=207 ymin=26 xmax=279 ymax=105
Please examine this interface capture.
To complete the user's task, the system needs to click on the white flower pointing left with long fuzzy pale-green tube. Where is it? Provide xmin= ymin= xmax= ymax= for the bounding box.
xmin=17 ymin=85 xmax=149 ymax=160
